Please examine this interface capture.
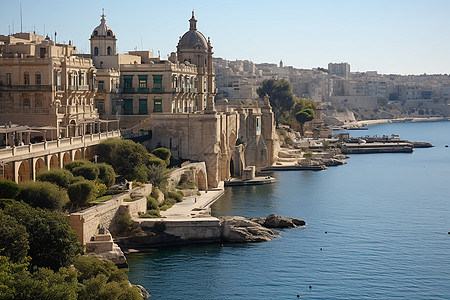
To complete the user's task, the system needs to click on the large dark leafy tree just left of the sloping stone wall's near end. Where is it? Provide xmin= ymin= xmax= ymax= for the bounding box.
xmin=0 ymin=200 xmax=83 ymax=271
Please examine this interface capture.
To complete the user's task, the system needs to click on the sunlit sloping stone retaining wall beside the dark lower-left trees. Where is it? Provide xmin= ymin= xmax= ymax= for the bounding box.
xmin=69 ymin=184 xmax=152 ymax=245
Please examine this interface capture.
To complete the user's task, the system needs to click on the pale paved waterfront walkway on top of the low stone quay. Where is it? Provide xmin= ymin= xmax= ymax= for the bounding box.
xmin=161 ymin=181 xmax=224 ymax=220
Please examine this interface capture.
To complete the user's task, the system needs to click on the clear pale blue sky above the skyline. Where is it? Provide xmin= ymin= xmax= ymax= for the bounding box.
xmin=0 ymin=0 xmax=450 ymax=75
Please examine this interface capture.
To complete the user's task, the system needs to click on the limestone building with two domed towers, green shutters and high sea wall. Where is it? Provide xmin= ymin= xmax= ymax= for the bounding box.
xmin=85 ymin=13 xmax=275 ymax=187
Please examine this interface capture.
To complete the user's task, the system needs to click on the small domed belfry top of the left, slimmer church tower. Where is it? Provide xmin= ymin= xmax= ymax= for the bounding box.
xmin=89 ymin=13 xmax=117 ymax=56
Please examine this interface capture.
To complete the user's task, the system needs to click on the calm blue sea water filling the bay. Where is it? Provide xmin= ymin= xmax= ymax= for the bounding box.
xmin=128 ymin=122 xmax=450 ymax=299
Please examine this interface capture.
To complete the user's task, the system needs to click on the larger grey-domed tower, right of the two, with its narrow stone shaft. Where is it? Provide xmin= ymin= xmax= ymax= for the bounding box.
xmin=177 ymin=11 xmax=215 ymax=111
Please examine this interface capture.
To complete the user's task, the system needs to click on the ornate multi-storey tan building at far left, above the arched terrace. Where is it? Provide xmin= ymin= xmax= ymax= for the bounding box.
xmin=0 ymin=33 xmax=108 ymax=139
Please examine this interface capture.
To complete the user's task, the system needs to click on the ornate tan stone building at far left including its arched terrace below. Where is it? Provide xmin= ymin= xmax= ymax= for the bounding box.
xmin=0 ymin=33 xmax=120 ymax=182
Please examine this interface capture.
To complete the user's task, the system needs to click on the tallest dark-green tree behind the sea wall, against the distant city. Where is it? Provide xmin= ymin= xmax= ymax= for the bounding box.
xmin=256 ymin=79 xmax=294 ymax=122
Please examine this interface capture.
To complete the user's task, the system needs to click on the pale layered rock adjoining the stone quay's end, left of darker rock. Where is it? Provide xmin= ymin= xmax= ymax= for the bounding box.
xmin=219 ymin=216 xmax=276 ymax=243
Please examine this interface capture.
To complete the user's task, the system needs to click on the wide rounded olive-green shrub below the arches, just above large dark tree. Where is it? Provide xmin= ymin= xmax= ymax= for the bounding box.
xmin=16 ymin=181 xmax=68 ymax=210
